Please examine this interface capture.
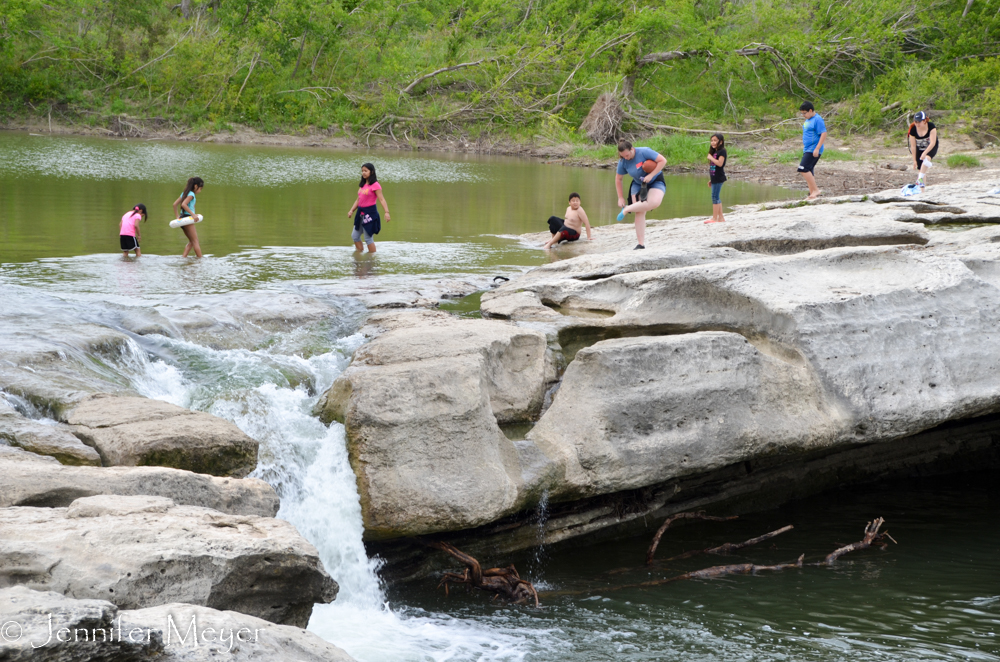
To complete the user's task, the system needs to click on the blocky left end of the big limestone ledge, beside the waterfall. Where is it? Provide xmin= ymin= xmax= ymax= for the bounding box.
xmin=318 ymin=312 xmax=555 ymax=538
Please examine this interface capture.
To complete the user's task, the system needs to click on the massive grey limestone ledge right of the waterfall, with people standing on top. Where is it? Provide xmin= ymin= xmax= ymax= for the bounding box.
xmin=320 ymin=182 xmax=1000 ymax=576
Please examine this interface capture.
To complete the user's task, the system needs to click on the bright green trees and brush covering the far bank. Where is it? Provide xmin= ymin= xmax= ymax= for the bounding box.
xmin=0 ymin=0 xmax=1000 ymax=138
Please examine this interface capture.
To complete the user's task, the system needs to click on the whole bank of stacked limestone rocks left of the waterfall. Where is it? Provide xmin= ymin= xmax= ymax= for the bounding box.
xmin=0 ymin=293 xmax=360 ymax=662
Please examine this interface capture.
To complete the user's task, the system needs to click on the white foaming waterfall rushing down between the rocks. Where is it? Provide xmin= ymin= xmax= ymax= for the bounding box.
xmin=113 ymin=335 xmax=559 ymax=662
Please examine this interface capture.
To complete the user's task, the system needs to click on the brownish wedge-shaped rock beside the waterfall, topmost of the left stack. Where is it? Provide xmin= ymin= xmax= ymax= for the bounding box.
xmin=62 ymin=394 xmax=258 ymax=478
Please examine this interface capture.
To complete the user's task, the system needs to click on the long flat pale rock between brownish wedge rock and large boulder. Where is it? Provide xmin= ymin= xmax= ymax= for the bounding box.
xmin=0 ymin=446 xmax=279 ymax=517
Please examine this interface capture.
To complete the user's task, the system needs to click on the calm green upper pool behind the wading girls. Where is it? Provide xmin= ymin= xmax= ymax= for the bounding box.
xmin=0 ymin=133 xmax=797 ymax=271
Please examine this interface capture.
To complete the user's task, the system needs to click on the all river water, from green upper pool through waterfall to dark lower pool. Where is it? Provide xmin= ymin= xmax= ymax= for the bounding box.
xmin=0 ymin=134 xmax=1000 ymax=662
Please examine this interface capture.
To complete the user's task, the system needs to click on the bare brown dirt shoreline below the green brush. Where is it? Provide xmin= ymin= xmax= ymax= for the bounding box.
xmin=7 ymin=115 xmax=1000 ymax=197
